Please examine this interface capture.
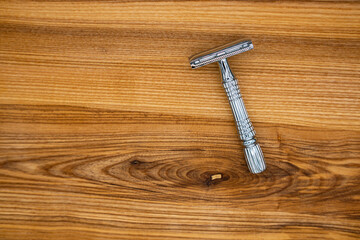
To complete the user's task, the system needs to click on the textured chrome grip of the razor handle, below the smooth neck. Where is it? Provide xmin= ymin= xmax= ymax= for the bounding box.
xmin=223 ymin=78 xmax=266 ymax=173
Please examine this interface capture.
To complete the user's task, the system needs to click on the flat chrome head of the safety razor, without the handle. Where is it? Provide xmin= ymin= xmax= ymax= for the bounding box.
xmin=190 ymin=40 xmax=254 ymax=68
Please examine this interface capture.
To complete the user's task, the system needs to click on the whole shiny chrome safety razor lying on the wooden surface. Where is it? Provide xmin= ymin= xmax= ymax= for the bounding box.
xmin=190 ymin=40 xmax=266 ymax=173
